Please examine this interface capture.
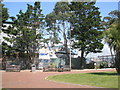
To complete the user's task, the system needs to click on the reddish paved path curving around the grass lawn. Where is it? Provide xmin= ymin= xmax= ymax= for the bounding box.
xmin=0 ymin=69 xmax=115 ymax=88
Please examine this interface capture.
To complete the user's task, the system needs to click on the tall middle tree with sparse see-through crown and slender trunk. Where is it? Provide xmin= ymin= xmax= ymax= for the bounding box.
xmin=46 ymin=1 xmax=70 ymax=65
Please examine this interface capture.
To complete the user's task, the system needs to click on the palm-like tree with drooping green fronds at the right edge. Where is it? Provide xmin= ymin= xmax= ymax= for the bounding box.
xmin=104 ymin=23 xmax=120 ymax=75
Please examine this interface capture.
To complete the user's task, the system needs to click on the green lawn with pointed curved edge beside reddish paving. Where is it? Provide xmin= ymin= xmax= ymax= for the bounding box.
xmin=47 ymin=72 xmax=118 ymax=88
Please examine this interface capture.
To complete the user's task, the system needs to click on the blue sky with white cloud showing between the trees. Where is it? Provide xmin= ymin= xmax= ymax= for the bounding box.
xmin=3 ymin=0 xmax=118 ymax=57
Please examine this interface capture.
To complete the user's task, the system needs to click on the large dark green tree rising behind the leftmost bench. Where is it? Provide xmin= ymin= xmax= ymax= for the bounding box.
xmin=2 ymin=2 xmax=43 ymax=68
